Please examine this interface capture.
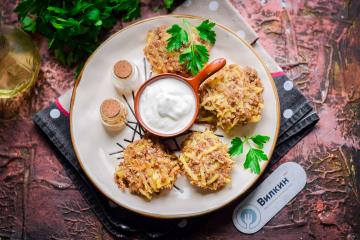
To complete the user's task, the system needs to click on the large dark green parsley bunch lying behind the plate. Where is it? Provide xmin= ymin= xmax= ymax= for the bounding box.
xmin=15 ymin=0 xmax=174 ymax=70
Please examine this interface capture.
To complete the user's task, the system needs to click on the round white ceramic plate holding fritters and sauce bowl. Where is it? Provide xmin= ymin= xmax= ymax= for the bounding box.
xmin=70 ymin=15 xmax=280 ymax=218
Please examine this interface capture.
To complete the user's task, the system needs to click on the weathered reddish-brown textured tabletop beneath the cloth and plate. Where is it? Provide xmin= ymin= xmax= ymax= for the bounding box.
xmin=0 ymin=0 xmax=360 ymax=239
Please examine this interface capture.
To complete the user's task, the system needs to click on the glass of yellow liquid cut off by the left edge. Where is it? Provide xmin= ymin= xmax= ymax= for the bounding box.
xmin=0 ymin=26 xmax=40 ymax=98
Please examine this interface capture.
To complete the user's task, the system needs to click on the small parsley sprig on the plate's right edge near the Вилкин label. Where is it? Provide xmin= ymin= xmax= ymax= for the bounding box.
xmin=228 ymin=134 xmax=270 ymax=174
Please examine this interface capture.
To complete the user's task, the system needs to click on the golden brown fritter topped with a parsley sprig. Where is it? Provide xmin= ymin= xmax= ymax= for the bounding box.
xmin=144 ymin=25 xmax=212 ymax=77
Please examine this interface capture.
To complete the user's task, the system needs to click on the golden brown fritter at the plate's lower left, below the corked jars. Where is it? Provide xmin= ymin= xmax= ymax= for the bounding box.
xmin=115 ymin=139 xmax=180 ymax=200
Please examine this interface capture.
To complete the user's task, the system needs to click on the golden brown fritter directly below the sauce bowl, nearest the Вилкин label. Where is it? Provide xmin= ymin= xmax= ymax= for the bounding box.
xmin=179 ymin=130 xmax=234 ymax=191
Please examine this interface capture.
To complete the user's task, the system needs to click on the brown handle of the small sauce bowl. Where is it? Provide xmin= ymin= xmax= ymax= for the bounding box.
xmin=188 ymin=58 xmax=226 ymax=93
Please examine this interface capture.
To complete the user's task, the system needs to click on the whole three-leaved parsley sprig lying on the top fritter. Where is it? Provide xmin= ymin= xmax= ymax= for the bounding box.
xmin=166 ymin=19 xmax=216 ymax=75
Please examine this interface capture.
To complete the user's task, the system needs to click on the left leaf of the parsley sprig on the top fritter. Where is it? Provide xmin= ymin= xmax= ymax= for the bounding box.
xmin=166 ymin=24 xmax=189 ymax=52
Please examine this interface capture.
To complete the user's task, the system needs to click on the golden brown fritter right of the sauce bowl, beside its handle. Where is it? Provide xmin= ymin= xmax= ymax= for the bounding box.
xmin=200 ymin=64 xmax=264 ymax=131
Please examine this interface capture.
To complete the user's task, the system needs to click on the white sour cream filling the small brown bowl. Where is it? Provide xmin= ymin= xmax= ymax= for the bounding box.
xmin=139 ymin=78 xmax=196 ymax=134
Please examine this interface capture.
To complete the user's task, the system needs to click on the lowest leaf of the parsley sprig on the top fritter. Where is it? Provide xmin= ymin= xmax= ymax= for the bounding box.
xmin=179 ymin=44 xmax=209 ymax=75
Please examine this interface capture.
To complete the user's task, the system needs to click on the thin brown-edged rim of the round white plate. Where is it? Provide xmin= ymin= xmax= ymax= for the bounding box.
xmin=69 ymin=14 xmax=281 ymax=219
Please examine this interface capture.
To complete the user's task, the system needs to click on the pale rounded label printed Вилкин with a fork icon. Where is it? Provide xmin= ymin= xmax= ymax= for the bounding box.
xmin=233 ymin=162 xmax=306 ymax=234
